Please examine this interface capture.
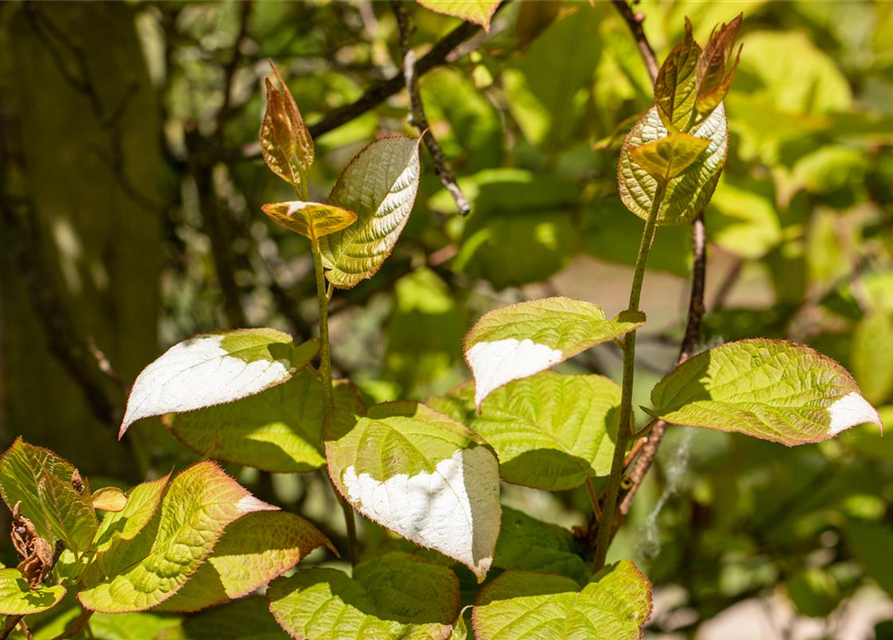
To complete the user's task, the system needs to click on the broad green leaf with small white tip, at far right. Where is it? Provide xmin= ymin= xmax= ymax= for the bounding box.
xmin=651 ymin=339 xmax=883 ymax=446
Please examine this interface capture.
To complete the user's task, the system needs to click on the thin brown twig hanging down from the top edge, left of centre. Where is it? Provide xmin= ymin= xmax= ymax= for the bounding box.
xmin=391 ymin=0 xmax=471 ymax=216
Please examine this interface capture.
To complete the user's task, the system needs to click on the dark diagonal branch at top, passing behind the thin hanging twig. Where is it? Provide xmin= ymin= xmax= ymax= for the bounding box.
xmin=243 ymin=0 xmax=512 ymax=160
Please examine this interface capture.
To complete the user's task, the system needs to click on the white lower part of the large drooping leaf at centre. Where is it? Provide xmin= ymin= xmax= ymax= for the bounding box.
xmin=341 ymin=447 xmax=502 ymax=581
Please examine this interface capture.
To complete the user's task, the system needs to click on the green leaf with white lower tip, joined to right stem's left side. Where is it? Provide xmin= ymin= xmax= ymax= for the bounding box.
xmin=465 ymin=297 xmax=645 ymax=410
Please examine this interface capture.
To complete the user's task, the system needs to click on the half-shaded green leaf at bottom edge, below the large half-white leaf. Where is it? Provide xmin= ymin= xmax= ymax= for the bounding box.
xmin=267 ymin=553 xmax=459 ymax=640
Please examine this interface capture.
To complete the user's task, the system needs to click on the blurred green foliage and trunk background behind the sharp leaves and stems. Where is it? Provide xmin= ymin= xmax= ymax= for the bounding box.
xmin=0 ymin=0 xmax=893 ymax=639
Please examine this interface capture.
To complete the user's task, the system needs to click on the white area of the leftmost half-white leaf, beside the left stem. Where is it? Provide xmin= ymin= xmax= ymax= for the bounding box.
xmin=118 ymin=334 xmax=291 ymax=439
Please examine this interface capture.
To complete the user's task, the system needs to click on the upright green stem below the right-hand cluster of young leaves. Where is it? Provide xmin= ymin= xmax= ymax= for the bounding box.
xmin=595 ymin=183 xmax=666 ymax=571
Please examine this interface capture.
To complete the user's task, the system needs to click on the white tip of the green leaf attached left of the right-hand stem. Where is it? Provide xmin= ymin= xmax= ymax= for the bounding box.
xmin=466 ymin=338 xmax=564 ymax=411
